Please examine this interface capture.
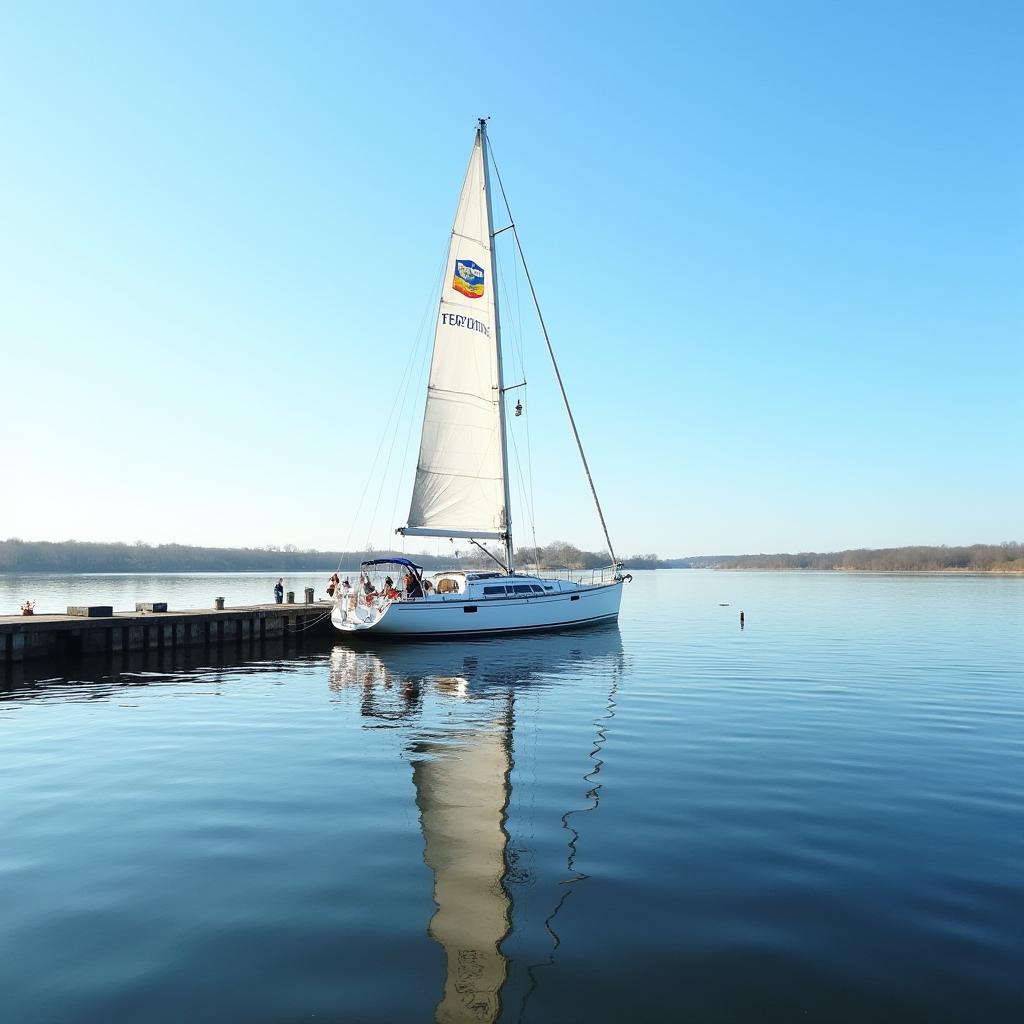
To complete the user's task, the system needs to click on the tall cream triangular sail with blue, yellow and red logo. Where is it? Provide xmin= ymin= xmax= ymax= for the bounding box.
xmin=408 ymin=132 xmax=506 ymax=536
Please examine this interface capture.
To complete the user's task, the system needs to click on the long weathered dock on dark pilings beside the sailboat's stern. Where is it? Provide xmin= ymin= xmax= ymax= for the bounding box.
xmin=0 ymin=601 xmax=335 ymax=665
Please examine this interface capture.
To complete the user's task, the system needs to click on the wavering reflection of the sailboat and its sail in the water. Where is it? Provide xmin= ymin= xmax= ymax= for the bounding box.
xmin=331 ymin=627 xmax=624 ymax=1024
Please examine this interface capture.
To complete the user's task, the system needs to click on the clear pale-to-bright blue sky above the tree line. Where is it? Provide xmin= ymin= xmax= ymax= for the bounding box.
xmin=0 ymin=0 xmax=1024 ymax=557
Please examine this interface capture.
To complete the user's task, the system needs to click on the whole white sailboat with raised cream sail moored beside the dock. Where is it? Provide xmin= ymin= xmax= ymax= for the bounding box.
xmin=331 ymin=118 xmax=630 ymax=639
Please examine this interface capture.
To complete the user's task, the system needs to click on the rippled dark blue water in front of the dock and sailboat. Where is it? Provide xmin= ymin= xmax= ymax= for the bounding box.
xmin=0 ymin=570 xmax=1024 ymax=1024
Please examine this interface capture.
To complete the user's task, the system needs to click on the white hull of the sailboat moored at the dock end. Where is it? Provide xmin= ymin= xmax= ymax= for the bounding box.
xmin=331 ymin=580 xmax=623 ymax=638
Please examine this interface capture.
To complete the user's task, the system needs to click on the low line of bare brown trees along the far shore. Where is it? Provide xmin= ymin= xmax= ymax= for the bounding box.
xmin=0 ymin=538 xmax=1024 ymax=574
